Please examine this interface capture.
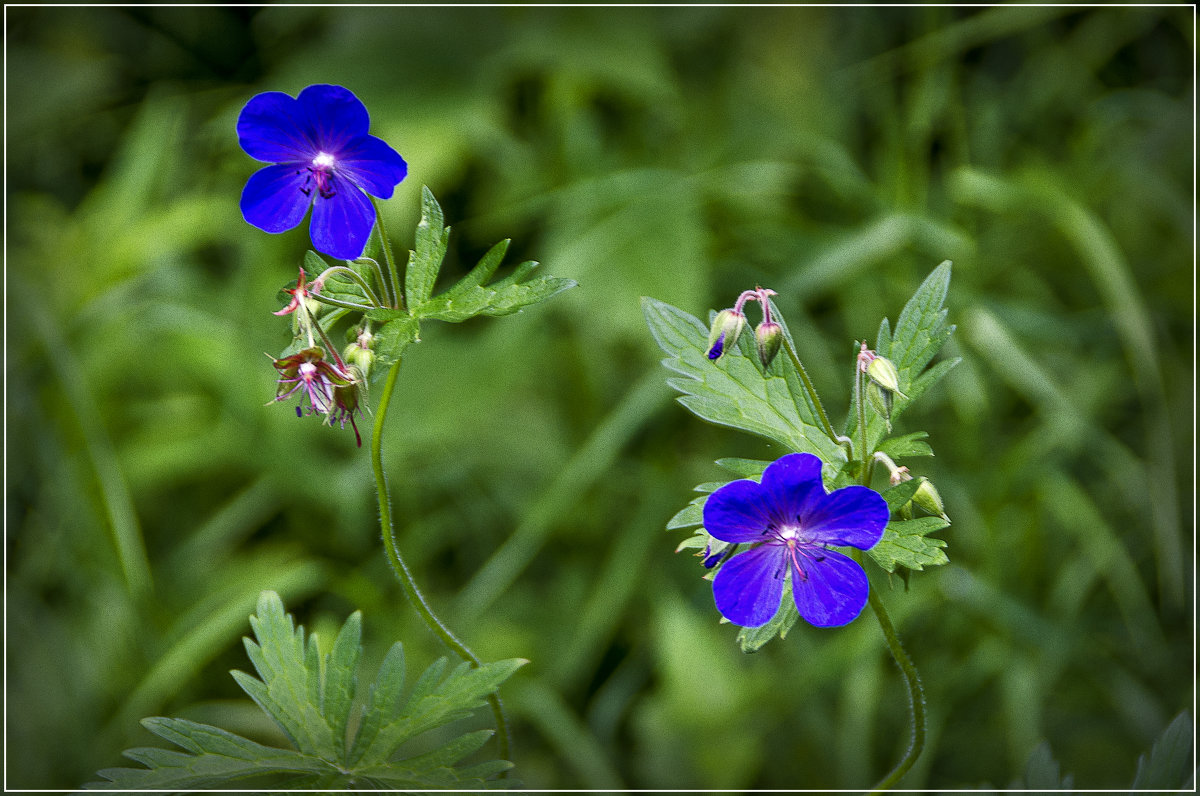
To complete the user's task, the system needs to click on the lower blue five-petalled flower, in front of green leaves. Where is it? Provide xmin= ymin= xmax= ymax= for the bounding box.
xmin=704 ymin=454 xmax=888 ymax=628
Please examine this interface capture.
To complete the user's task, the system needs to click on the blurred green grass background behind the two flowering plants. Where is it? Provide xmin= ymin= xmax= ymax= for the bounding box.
xmin=6 ymin=6 xmax=1195 ymax=789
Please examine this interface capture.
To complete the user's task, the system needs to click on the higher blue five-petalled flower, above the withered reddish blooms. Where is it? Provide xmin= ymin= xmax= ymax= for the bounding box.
xmin=238 ymin=85 xmax=408 ymax=259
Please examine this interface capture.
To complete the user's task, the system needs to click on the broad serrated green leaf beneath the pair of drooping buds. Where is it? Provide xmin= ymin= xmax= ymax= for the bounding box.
xmin=642 ymin=298 xmax=846 ymax=462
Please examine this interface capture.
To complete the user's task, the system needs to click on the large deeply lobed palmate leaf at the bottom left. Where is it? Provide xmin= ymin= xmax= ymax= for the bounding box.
xmin=86 ymin=592 xmax=526 ymax=790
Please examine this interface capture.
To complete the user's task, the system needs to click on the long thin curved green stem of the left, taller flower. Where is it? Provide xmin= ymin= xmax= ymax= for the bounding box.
xmin=371 ymin=359 xmax=509 ymax=763
